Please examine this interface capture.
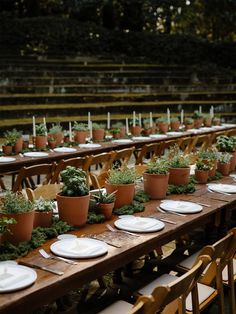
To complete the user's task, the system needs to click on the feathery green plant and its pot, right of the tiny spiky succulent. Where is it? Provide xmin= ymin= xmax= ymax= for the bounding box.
xmin=105 ymin=166 xmax=138 ymax=208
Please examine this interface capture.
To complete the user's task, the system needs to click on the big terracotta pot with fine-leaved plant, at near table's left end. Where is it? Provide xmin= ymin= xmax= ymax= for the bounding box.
xmin=0 ymin=191 xmax=34 ymax=244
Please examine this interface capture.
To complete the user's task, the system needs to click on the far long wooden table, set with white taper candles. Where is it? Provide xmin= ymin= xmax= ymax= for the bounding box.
xmin=0 ymin=125 xmax=236 ymax=174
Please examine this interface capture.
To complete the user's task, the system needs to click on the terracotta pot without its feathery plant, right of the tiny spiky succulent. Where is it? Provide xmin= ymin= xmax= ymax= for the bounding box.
xmin=105 ymin=182 xmax=135 ymax=208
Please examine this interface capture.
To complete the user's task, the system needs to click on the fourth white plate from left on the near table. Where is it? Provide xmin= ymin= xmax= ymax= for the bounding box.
xmin=160 ymin=200 xmax=202 ymax=214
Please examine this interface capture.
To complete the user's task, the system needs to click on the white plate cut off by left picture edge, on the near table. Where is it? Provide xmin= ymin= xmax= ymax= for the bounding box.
xmin=0 ymin=262 xmax=37 ymax=293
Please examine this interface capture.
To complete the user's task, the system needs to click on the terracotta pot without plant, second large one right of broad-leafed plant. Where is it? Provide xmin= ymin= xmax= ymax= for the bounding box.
xmin=143 ymin=173 xmax=169 ymax=200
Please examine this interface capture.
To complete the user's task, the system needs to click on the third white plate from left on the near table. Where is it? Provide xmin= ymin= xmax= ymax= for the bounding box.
xmin=114 ymin=217 xmax=165 ymax=232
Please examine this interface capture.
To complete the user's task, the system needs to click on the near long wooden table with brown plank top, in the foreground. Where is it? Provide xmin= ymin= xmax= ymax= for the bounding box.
xmin=0 ymin=177 xmax=236 ymax=314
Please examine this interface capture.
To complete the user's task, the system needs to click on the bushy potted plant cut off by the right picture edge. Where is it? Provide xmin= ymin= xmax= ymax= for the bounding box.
xmin=216 ymin=135 xmax=236 ymax=171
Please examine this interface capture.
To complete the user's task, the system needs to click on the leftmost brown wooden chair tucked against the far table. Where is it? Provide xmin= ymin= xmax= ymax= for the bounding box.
xmin=12 ymin=162 xmax=56 ymax=192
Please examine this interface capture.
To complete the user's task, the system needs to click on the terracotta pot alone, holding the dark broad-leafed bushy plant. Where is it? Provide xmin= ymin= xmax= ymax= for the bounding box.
xmin=57 ymin=194 xmax=90 ymax=227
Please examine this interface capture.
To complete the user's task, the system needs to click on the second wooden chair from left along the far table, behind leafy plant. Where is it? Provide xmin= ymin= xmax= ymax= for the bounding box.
xmin=51 ymin=156 xmax=88 ymax=183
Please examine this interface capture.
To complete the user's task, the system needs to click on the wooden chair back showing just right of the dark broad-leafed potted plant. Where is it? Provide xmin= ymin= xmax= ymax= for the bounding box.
xmin=84 ymin=151 xmax=115 ymax=189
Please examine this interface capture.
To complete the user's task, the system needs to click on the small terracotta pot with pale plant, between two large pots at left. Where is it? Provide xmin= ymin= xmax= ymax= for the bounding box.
xmin=33 ymin=197 xmax=56 ymax=228
